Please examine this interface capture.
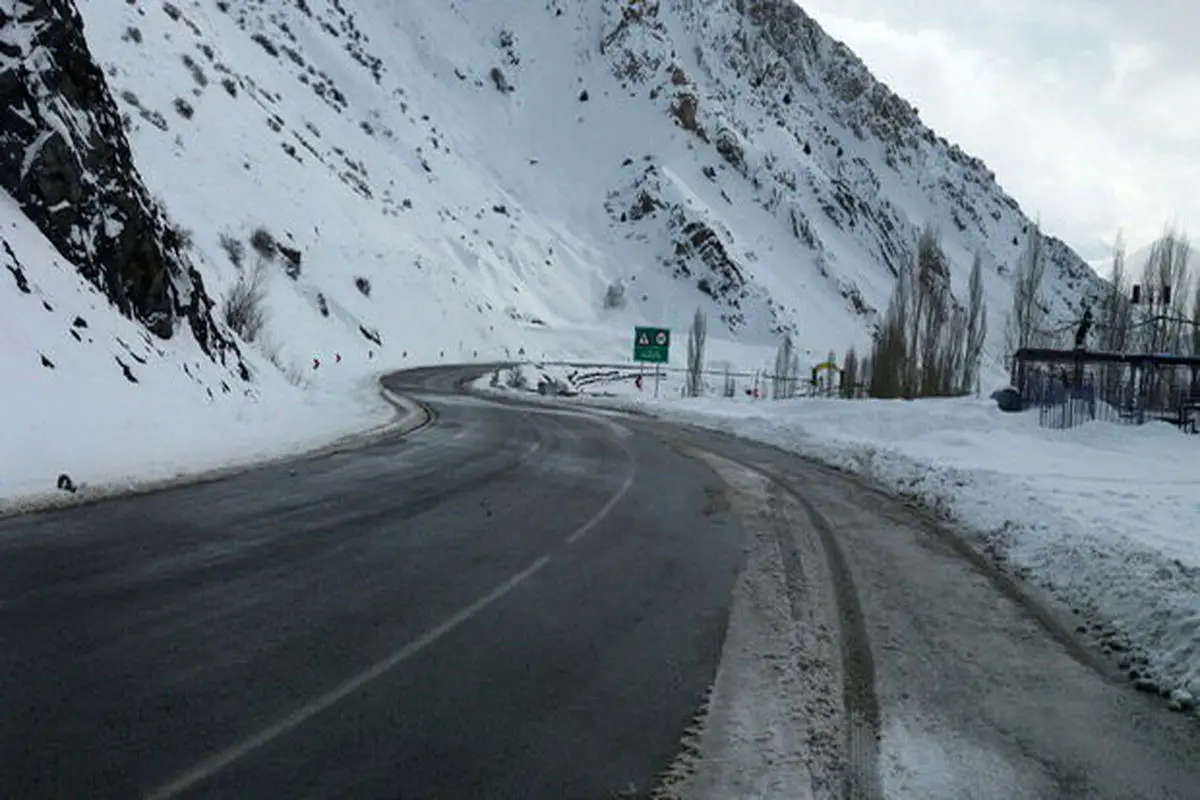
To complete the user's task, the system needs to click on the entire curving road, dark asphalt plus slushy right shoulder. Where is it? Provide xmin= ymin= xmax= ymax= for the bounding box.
xmin=0 ymin=367 xmax=1200 ymax=800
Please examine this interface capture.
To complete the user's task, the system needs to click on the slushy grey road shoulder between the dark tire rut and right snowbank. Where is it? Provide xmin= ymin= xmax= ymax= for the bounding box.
xmin=657 ymin=422 xmax=1200 ymax=800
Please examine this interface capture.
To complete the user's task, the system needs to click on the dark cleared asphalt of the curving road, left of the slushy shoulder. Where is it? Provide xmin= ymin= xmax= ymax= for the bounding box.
xmin=0 ymin=371 xmax=742 ymax=800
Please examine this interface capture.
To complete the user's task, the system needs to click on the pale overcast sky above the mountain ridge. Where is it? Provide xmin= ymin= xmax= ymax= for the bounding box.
xmin=799 ymin=0 xmax=1200 ymax=258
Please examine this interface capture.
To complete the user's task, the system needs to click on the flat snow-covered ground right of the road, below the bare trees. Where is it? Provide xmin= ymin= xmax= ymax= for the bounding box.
xmin=479 ymin=365 xmax=1200 ymax=697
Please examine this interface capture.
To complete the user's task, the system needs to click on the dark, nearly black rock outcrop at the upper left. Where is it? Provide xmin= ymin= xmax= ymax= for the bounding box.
xmin=0 ymin=0 xmax=233 ymax=360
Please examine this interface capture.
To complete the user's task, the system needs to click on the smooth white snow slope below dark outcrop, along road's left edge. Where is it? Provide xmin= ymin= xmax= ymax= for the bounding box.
xmin=0 ymin=192 xmax=392 ymax=512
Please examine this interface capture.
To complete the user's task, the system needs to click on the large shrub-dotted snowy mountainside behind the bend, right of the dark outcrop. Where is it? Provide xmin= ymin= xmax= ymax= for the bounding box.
xmin=83 ymin=0 xmax=1088 ymax=357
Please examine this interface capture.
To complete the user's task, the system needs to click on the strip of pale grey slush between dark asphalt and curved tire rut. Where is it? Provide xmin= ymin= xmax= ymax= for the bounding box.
xmin=649 ymin=450 xmax=845 ymax=800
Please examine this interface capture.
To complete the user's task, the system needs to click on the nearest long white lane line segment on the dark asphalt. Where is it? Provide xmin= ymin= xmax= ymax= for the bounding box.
xmin=146 ymin=555 xmax=550 ymax=800
